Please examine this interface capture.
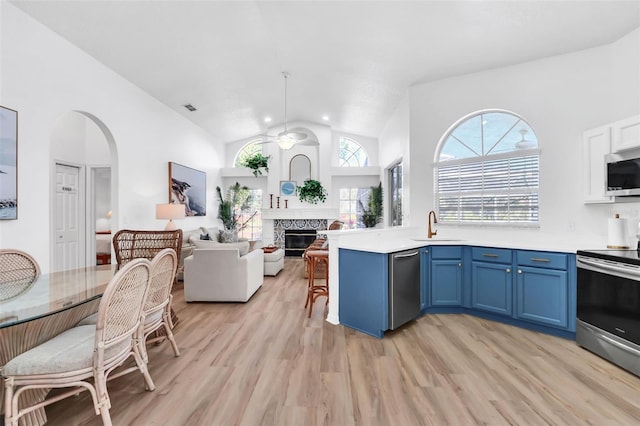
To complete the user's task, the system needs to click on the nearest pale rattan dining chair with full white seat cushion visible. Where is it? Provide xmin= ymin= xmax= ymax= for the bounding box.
xmin=2 ymin=259 xmax=155 ymax=426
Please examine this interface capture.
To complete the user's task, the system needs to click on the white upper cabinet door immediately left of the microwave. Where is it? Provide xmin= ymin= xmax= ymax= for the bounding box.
xmin=582 ymin=126 xmax=614 ymax=204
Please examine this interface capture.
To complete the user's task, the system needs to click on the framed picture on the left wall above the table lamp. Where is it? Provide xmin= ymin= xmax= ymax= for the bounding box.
xmin=169 ymin=162 xmax=207 ymax=216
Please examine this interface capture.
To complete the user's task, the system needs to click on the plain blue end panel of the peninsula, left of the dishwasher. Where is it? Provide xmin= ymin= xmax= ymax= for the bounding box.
xmin=339 ymin=249 xmax=389 ymax=337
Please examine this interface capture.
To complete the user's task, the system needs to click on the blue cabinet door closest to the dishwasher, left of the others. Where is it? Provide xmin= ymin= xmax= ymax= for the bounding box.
xmin=431 ymin=259 xmax=462 ymax=306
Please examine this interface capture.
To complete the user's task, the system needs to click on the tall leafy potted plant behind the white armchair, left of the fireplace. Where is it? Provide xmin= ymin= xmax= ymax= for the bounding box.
xmin=216 ymin=182 xmax=257 ymax=243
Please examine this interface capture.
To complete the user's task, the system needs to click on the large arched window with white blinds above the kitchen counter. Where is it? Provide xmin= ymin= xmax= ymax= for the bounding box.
xmin=434 ymin=110 xmax=540 ymax=226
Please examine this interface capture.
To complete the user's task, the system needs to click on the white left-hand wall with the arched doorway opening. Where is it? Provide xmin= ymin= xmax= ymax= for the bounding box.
xmin=0 ymin=2 xmax=224 ymax=272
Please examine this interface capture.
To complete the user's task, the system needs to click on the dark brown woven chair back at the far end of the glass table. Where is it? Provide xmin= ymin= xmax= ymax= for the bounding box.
xmin=113 ymin=229 xmax=182 ymax=268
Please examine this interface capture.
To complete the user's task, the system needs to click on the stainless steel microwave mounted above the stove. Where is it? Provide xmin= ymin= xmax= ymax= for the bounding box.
xmin=605 ymin=149 xmax=640 ymax=196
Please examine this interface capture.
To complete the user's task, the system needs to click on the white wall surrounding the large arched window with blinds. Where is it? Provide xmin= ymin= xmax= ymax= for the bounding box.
xmin=408 ymin=30 xmax=640 ymax=246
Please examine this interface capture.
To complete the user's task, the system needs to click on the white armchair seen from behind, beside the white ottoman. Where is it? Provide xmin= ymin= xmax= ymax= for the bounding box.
xmin=184 ymin=244 xmax=264 ymax=302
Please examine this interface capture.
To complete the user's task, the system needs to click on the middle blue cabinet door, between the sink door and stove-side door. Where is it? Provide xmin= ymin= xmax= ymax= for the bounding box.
xmin=471 ymin=262 xmax=513 ymax=316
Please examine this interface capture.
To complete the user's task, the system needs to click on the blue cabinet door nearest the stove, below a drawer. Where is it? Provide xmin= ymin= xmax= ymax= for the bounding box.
xmin=516 ymin=266 xmax=569 ymax=329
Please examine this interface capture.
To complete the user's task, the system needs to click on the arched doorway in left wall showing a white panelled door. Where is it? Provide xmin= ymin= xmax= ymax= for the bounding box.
xmin=50 ymin=111 xmax=118 ymax=271
